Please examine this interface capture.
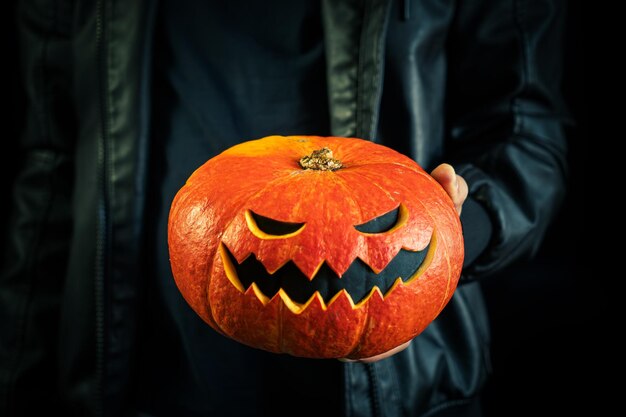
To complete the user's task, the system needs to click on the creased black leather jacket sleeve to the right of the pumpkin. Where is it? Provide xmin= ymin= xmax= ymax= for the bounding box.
xmin=447 ymin=0 xmax=566 ymax=278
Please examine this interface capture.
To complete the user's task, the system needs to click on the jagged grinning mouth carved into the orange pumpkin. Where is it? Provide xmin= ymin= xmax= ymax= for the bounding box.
xmin=221 ymin=237 xmax=436 ymax=305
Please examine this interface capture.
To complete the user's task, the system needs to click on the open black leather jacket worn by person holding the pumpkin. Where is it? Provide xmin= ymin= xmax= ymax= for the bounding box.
xmin=0 ymin=0 xmax=566 ymax=417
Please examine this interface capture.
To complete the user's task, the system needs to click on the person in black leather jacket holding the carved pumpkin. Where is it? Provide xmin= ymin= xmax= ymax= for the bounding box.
xmin=0 ymin=0 xmax=566 ymax=417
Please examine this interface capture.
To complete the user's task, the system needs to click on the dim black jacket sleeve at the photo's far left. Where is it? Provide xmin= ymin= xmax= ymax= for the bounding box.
xmin=0 ymin=1 xmax=74 ymax=416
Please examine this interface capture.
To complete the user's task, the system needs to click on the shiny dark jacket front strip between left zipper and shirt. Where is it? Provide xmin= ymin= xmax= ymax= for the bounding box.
xmin=92 ymin=0 xmax=155 ymax=415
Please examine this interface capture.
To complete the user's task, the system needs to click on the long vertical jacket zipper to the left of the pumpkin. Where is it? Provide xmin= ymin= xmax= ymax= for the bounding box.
xmin=94 ymin=0 xmax=108 ymax=417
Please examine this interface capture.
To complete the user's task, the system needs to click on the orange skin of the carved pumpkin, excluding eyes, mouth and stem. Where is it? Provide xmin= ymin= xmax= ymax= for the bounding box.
xmin=168 ymin=136 xmax=463 ymax=359
